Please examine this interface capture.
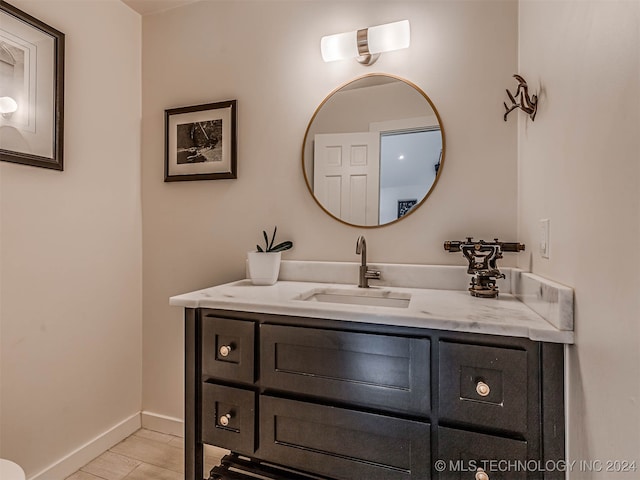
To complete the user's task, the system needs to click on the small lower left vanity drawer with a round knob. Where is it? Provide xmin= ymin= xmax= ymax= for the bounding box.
xmin=201 ymin=383 xmax=256 ymax=454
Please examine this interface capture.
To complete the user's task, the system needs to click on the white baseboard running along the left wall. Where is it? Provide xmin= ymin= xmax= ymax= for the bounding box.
xmin=28 ymin=413 xmax=141 ymax=480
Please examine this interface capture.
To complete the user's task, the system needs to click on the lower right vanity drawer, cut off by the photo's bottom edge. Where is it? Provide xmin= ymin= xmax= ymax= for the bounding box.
xmin=434 ymin=427 xmax=528 ymax=480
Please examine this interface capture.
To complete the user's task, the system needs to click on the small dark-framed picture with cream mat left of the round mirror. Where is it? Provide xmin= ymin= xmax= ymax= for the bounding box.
xmin=164 ymin=100 xmax=237 ymax=182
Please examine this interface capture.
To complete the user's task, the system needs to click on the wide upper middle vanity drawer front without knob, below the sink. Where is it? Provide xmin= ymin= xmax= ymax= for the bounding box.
xmin=260 ymin=324 xmax=430 ymax=415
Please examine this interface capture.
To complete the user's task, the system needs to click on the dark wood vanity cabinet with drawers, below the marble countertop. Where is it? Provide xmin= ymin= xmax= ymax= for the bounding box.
xmin=185 ymin=309 xmax=564 ymax=480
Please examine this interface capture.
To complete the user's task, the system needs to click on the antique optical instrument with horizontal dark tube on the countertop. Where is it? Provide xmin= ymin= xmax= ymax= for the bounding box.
xmin=444 ymin=237 xmax=524 ymax=298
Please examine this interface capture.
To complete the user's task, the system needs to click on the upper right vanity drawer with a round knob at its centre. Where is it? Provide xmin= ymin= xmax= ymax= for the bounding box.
xmin=439 ymin=342 xmax=528 ymax=433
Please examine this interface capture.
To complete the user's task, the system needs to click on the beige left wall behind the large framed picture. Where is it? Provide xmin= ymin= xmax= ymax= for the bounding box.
xmin=0 ymin=0 xmax=142 ymax=479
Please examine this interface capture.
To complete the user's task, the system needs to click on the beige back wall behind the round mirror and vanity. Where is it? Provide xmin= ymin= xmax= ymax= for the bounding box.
xmin=142 ymin=0 xmax=517 ymax=424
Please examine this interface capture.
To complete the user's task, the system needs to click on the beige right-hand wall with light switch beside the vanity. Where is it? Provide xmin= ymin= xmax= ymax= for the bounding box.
xmin=518 ymin=1 xmax=640 ymax=472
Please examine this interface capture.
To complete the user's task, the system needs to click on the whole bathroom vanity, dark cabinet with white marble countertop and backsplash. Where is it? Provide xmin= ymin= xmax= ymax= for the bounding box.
xmin=171 ymin=262 xmax=573 ymax=480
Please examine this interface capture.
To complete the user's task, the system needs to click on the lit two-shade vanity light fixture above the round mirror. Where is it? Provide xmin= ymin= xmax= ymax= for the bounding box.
xmin=320 ymin=20 xmax=411 ymax=65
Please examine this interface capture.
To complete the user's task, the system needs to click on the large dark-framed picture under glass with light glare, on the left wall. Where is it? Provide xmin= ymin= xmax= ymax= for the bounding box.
xmin=0 ymin=1 xmax=65 ymax=171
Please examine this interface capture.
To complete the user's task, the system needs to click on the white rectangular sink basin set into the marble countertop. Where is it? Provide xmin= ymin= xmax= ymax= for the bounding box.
xmin=296 ymin=288 xmax=411 ymax=308
